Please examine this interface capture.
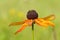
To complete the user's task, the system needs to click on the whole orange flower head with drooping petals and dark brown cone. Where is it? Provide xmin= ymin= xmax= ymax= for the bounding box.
xmin=9 ymin=10 xmax=55 ymax=34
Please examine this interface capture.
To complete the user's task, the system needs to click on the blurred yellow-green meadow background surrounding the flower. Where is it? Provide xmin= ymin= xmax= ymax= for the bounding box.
xmin=0 ymin=0 xmax=60 ymax=40
